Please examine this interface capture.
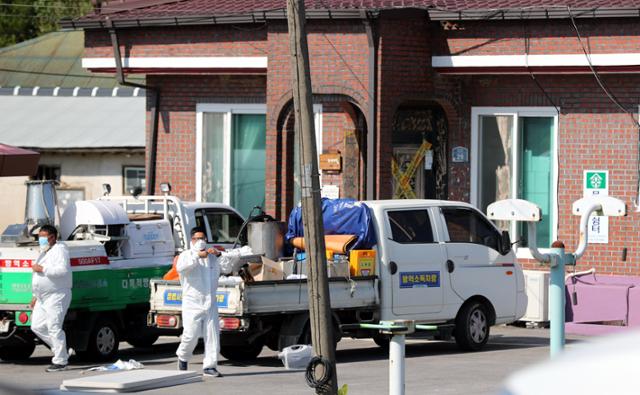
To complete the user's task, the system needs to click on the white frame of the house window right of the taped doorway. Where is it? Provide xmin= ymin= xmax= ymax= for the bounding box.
xmin=470 ymin=107 xmax=559 ymax=259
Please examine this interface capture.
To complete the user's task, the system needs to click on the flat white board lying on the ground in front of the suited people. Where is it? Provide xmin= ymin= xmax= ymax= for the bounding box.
xmin=60 ymin=370 xmax=202 ymax=393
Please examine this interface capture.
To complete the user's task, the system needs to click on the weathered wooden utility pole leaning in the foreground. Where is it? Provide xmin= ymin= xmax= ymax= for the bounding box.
xmin=287 ymin=0 xmax=338 ymax=394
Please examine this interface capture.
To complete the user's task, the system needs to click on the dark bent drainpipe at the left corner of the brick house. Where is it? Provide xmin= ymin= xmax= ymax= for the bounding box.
xmin=106 ymin=17 xmax=160 ymax=195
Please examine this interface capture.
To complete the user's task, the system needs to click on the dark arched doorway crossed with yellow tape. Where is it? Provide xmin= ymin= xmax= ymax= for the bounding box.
xmin=391 ymin=104 xmax=448 ymax=199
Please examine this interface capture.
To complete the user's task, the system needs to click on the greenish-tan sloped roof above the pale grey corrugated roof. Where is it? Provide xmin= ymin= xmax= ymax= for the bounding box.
xmin=0 ymin=31 xmax=144 ymax=88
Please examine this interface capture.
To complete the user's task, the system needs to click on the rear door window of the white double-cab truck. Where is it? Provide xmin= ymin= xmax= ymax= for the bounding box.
xmin=387 ymin=210 xmax=433 ymax=243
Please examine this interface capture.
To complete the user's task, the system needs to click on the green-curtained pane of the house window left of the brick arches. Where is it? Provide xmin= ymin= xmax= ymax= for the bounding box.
xmin=230 ymin=114 xmax=267 ymax=216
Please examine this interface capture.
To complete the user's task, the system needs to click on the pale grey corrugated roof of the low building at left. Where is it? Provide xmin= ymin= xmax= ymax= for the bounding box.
xmin=0 ymin=96 xmax=146 ymax=149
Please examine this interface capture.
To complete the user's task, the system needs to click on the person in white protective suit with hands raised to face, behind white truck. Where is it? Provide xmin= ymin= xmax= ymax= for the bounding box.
xmin=176 ymin=228 xmax=222 ymax=377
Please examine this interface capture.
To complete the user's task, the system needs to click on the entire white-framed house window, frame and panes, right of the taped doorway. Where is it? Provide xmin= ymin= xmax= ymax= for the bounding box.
xmin=471 ymin=107 xmax=558 ymax=251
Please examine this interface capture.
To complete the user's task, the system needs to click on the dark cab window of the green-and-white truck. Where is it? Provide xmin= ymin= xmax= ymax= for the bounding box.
xmin=195 ymin=209 xmax=247 ymax=244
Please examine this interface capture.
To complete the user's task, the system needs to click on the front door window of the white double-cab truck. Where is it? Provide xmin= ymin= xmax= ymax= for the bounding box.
xmin=442 ymin=207 xmax=500 ymax=251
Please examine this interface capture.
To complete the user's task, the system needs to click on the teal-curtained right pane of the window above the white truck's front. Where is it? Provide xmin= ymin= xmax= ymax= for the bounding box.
xmin=519 ymin=117 xmax=554 ymax=248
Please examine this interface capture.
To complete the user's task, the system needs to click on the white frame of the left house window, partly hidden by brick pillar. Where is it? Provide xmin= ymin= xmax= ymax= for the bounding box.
xmin=195 ymin=103 xmax=322 ymax=205
